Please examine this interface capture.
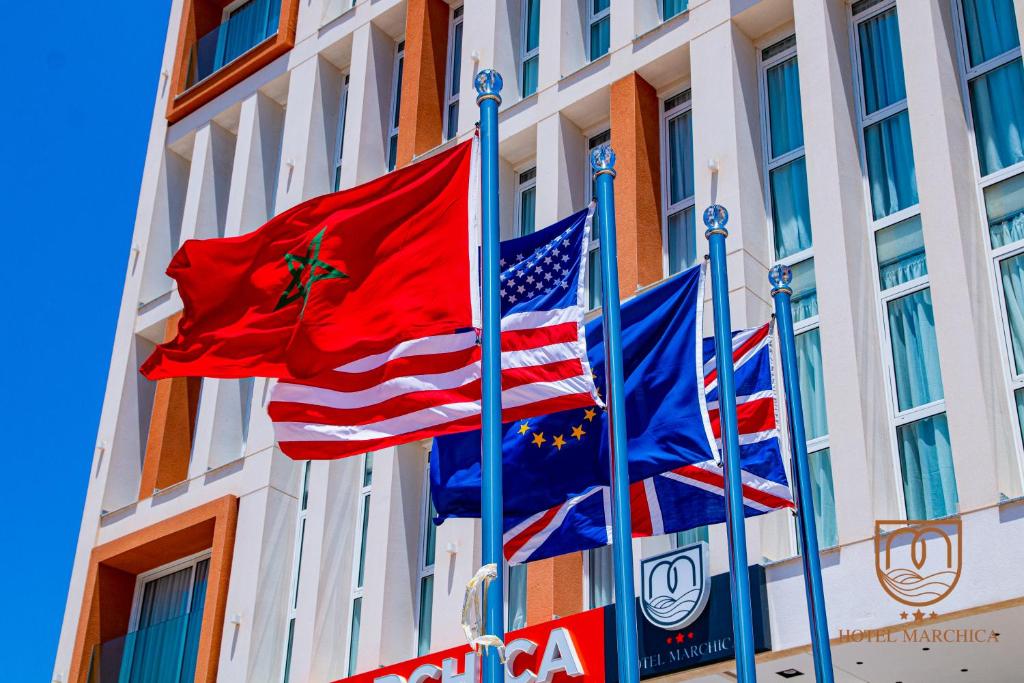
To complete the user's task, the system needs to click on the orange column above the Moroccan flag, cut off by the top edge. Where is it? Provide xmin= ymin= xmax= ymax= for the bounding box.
xmin=397 ymin=0 xmax=451 ymax=168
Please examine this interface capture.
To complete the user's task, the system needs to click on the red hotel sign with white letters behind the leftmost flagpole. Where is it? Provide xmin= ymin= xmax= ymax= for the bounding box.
xmin=335 ymin=609 xmax=605 ymax=683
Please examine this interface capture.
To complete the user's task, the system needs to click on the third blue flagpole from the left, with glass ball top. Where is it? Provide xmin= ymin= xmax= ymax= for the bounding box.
xmin=703 ymin=204 xmax=758 ymax=683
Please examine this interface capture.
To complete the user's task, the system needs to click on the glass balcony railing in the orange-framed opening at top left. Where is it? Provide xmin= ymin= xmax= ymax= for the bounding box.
xmin=185 ymin=0 xmax=281 ymax=89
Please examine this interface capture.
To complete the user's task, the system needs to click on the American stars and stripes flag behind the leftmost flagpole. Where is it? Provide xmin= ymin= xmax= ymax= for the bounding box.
xmin=267 ymin=210 xmax=600 ymax=460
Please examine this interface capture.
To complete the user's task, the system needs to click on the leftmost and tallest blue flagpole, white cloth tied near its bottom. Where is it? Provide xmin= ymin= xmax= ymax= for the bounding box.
xmin=473 ymin=69 xmax=505 ymax=683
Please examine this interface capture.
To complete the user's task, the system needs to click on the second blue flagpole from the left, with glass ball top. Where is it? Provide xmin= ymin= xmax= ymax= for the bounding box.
xmin=590 ymin=144 xmax=640 ymax=683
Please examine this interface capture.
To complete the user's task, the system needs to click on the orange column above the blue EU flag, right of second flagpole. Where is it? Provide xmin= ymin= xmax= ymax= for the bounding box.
xmin=611 ymin=73 xmax=665 ymax=298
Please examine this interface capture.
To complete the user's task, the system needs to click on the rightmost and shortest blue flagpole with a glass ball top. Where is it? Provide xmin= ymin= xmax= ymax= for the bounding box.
xmin=768 ymin=264 xmax=833 ymax=683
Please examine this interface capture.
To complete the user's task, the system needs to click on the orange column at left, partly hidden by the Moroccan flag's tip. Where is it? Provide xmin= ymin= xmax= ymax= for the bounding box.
xmin=138 ymin=313 xmax=203 ymax=500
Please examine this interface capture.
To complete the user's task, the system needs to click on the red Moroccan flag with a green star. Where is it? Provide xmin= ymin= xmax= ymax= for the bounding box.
xmin=141 ymin=141 xmax=478 ymax=380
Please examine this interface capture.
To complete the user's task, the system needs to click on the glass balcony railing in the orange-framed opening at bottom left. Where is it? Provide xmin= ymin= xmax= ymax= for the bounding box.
xmin=87 ymin=610 xmax=203 ymax=683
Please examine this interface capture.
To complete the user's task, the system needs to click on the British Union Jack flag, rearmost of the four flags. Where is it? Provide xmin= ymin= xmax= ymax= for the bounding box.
xmin=504 ymin=325 xmax=794 ymax=564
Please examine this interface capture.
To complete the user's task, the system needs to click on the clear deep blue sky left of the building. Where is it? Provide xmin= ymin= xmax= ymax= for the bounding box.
xmin=0 ymin=0 xmax=170 ymax=682
